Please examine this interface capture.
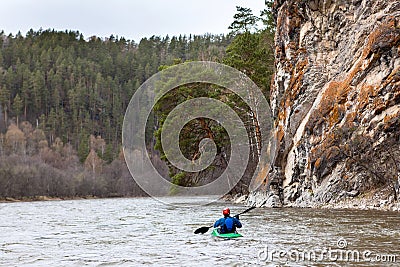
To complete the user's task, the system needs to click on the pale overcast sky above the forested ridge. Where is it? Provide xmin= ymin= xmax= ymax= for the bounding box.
xmin=0 ymin=0 xmax=265 ymax=42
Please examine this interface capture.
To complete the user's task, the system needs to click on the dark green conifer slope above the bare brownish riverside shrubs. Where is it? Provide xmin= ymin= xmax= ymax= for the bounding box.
xmin=0 ymin=30 xmax=229 ymax=155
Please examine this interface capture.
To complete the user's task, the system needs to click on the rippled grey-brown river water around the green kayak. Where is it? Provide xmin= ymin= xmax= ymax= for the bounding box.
xmin=0 ymin=197 xmax=400 ymax=267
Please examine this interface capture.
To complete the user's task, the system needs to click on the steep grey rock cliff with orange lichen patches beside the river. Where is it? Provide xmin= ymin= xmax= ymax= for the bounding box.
xmin=250 ymin=0 xmax=400 ymax=209
